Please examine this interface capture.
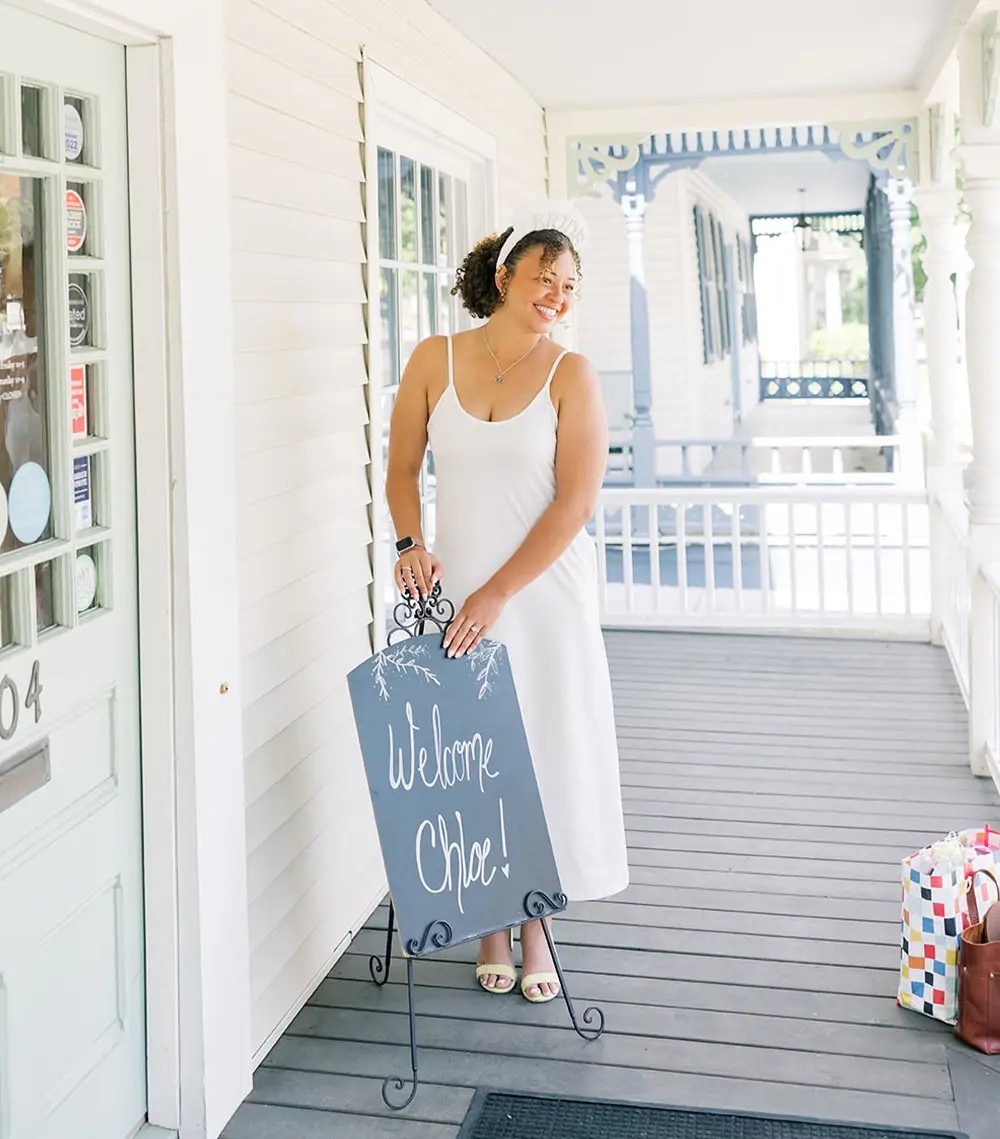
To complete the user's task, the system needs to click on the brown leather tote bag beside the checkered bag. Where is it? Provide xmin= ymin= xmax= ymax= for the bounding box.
xmin=954 ymin=870 xmax=1000 ymax=1056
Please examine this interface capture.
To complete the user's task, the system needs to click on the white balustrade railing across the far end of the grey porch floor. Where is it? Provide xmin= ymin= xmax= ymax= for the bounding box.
xmin=593 ymin=487 xmax=931 ymax=638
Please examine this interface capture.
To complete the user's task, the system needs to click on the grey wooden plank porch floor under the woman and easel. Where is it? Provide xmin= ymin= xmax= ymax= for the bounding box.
xmin=224 ymin=632 xmax=1000 ymax=1139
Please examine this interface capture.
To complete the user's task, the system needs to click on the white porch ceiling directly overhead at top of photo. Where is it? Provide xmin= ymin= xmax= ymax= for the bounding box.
xmin=429 ymin=0 xmax=975 ymax=111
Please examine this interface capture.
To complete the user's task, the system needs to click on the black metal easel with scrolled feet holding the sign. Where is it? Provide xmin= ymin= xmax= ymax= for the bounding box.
xmin=368 ymin=583 xmax=605 ymax=1112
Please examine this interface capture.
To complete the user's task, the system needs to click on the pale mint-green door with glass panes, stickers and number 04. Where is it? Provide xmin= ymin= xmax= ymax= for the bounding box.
xmin=0 ymin=11 xmax=146 ymax=1139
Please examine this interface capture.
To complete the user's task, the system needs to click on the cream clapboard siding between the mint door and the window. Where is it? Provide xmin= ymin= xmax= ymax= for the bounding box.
xmin=228 ymin=0 xmax=547 ymax=1058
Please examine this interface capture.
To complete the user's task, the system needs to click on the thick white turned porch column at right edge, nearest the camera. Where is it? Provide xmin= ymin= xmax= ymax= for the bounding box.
xmin=958 ymin=3 xmax=1000 ymax=775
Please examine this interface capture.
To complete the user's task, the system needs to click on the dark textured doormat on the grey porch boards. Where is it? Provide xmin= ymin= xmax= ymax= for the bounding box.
xmin=458 ymin=1090 xmax=966 ymax=1139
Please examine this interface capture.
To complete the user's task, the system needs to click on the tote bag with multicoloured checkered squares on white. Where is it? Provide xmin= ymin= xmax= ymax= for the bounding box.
xmin=896 ymin=827 xmax=1000 ymax=1024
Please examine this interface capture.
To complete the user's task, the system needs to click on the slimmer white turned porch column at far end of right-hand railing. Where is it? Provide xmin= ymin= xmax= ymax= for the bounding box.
xmin=915 ymin=182 xmax=965 ymax=645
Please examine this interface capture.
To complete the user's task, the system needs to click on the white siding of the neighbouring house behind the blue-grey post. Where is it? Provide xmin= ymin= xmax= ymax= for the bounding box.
xmin=577 ymin=171 xmax=759 ymax=466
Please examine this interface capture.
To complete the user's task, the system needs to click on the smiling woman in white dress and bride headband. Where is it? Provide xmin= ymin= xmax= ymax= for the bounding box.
xmin=386 ymin=207 xmax=629 ymax=1002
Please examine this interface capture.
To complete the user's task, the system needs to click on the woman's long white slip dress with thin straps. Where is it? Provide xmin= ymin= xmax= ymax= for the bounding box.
xmin=427 ymin=337 xmax=629 ymax=901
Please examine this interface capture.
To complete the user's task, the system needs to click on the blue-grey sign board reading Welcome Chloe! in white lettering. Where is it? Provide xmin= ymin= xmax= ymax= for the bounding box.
xmin=347 ymin=632 xmax=565 ymax=957
